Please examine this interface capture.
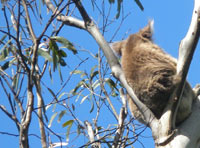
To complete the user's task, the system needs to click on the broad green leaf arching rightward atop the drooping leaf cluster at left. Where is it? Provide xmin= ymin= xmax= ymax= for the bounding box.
xmin=51 ymin=36 xmax=77 ymax=54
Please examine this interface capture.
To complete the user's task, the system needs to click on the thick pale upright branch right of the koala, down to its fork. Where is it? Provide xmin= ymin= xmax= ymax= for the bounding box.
xmin=155 ymin=0 xmax=200 ymax=145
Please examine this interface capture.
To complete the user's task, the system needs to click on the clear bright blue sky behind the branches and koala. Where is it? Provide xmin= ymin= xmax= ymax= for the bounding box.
xmin=0 ymin=0 xmax=200 ymax=148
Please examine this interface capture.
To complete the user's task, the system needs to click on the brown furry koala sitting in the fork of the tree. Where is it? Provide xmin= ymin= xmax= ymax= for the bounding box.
xmin=111 ymin=21 xmax=196 ymax=124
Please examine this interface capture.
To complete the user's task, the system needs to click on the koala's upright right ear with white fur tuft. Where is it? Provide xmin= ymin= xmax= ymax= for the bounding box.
xmin=140 ymin=20 xmax=154 ymax=40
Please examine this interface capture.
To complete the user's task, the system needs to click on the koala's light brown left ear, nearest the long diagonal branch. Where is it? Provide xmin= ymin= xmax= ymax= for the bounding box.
xmin=110 ymin=40 xmax=126 ymax=56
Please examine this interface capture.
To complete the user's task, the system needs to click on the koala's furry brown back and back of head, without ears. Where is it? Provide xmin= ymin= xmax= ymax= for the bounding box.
xmin=122 ymin=35 xmax=176 ymax=118
